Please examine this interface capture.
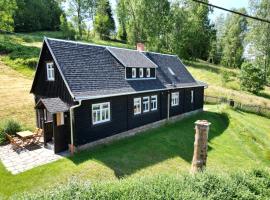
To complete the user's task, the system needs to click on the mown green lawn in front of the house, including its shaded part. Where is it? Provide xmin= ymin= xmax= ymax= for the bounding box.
xmin=0 ymin=106 xmax=270 ymax=196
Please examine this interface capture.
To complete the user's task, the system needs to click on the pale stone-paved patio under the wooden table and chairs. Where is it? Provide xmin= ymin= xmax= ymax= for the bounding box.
xmin=0 ymin=144 xmax=68 ymax=175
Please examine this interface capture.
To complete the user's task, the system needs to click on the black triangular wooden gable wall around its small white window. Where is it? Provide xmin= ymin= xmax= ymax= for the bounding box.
xmin=32 ymin=44 xmax=73 ymax=104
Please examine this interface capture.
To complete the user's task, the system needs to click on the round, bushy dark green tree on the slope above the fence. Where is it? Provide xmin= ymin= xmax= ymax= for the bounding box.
xmin=240 ymin=63 xmax=265 ymax=94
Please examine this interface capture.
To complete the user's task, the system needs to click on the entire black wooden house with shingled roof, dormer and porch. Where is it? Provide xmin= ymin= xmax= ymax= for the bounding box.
xmin=31 ymin=38 xmax=205 ymax=152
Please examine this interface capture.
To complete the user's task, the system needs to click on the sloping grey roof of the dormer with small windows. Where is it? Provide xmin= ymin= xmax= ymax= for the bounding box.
xmin=107 ymin=47 xmax=157 ymax=68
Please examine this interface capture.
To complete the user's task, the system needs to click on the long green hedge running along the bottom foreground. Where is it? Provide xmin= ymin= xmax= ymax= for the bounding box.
xmin=15 ymin=169 xmax=270 ymax=200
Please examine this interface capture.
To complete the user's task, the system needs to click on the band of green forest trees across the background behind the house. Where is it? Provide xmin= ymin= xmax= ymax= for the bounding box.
xmin=0 ymin=0 xmax=270 ymax=93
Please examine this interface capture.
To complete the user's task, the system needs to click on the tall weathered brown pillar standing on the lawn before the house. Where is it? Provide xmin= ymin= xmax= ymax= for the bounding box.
xmin=191 ymin=120 xmax=211 ymax=173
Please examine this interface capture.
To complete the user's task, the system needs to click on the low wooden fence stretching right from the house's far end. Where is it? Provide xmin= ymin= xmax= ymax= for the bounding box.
xmin=204 ymin=95 xmax=270 ymax=118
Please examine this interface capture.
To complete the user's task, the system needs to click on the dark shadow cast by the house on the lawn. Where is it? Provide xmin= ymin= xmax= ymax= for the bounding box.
xmin=70 ymin=112 xmax=229 ymax=178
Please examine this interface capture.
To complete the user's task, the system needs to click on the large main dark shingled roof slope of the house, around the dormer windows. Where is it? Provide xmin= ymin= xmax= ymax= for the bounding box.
xmin=45 ymin=39 xmax=203 ymax=99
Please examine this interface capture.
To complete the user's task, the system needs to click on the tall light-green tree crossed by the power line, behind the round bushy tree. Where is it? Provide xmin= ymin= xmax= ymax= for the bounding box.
xmin=221 ymin=8 xmax=247 ymax=68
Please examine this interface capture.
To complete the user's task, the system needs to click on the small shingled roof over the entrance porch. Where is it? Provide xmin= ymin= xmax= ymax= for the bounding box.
xmin=37 ymin=98 xmax=69 ymax=113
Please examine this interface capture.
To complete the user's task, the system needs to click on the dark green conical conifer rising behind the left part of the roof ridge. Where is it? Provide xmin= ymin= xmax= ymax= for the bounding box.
xmin=94 ymin=0 xmax=115 ymax=39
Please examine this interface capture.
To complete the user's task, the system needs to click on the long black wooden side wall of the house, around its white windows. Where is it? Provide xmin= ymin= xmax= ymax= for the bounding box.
xmin=74 ymin=87 xmax=204 ymax=146
